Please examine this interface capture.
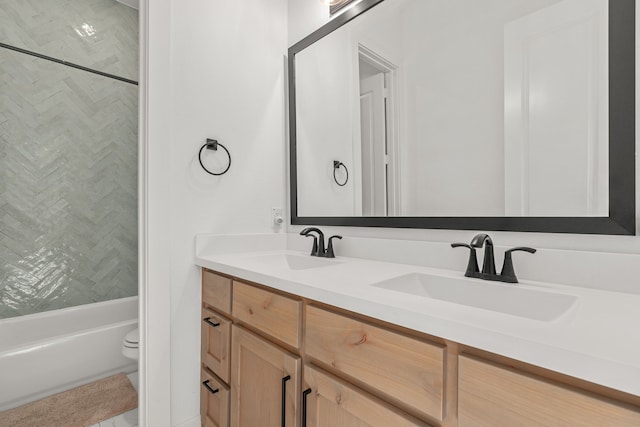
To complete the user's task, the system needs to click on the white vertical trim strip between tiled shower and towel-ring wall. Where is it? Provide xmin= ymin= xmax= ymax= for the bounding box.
xmin=138 ymin=0 xmax=172 ymax=427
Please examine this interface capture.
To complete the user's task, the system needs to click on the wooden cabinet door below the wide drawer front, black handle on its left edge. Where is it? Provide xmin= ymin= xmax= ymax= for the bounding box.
xmin=302 ymin=366 xmax=428 ymax=427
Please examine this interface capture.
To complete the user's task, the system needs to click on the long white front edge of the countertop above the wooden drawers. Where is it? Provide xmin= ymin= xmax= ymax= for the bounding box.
xmin=195 ymin=254 xmax=640 ymax=396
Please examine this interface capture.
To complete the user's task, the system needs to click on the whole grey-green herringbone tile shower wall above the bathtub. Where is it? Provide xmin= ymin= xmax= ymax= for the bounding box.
xmin=0 ymin=0 xmax=138 ymax=318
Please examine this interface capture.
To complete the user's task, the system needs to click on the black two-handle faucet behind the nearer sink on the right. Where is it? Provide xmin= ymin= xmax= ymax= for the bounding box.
xmin=451 ymin=233 xmax=536 ymax=283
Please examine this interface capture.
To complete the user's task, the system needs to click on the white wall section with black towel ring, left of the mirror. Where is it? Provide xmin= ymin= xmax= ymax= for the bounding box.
xmin=167 ymin=0 xmax=286 ymax=426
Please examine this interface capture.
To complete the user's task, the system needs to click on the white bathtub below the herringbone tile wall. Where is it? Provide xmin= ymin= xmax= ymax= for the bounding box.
xmin=0 ymin=297 xmax=138 ymax=411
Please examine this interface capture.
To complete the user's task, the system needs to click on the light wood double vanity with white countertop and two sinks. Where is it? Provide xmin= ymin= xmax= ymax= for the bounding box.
xmin=196 ymin=234 xmax=640 ymax=427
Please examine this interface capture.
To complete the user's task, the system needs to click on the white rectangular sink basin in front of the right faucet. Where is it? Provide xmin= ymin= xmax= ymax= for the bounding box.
xmin=373 ymin=273 xmax=578 ymax=321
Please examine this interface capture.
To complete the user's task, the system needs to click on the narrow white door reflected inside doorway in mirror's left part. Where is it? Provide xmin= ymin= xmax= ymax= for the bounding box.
xmin=360 ymin=73 xmax=387 ymax=216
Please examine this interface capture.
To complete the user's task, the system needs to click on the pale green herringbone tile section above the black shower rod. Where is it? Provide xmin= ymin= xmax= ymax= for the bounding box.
xmin=0 ymin=0 xmax=138 ymax=81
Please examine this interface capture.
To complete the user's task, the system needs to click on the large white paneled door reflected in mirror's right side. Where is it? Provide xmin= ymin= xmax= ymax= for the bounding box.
xmin=504 ymin=0 xmax=608 ymax=216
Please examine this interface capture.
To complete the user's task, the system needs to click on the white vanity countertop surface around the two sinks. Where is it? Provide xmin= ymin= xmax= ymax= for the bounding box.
xmin=195 ymin=235 xmax=640 ymax=396
